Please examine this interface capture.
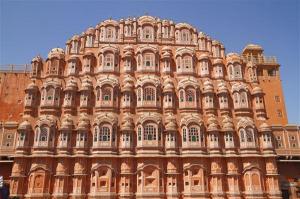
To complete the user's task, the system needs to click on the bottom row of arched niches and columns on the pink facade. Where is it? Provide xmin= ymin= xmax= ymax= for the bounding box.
xmin=11 ymin=164 xmax=279 ymax=196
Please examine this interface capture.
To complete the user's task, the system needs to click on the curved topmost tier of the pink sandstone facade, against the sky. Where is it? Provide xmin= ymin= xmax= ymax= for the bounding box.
xmin=66 ymin=16 xmax=213 ymax=47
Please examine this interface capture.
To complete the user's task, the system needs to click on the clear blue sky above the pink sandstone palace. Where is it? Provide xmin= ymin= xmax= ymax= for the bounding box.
xmin=0 ymin=0 xmax=300 ymax=124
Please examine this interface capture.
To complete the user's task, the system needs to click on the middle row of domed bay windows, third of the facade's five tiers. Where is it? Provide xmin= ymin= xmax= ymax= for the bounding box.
xmin=25 ymin=80 xmax=264 ymax=112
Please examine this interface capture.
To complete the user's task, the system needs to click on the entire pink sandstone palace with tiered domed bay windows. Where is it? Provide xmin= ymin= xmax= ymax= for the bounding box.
xmin=0 ymin=16 xmax=300 ymax=199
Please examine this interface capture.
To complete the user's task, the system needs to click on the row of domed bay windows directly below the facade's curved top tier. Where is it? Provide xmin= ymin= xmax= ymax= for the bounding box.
xmin=32 ymin=46 xmax=257 ymax=82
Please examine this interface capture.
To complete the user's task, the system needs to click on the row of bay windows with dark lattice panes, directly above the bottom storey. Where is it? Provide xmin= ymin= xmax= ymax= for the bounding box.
xmin=16 ymin=121 xmax=273 ymax=150
